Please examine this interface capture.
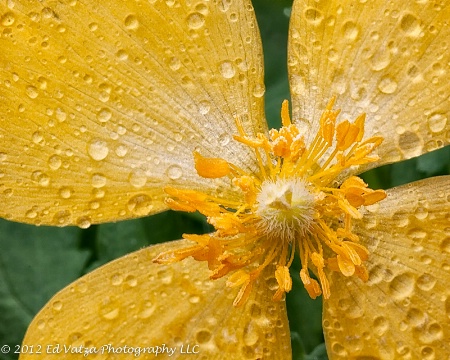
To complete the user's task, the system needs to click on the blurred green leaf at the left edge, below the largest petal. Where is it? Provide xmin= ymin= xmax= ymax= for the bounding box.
xmin=0 ymin=220 xmax=89 ymax=359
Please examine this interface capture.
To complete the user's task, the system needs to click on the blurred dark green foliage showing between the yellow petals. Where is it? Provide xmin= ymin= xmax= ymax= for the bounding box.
xmin=0 ymin=0 xmax=450 ymax=360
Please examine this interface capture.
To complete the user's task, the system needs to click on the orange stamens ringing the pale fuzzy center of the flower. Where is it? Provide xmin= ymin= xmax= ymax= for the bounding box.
xmin=154 ymin=99 xmax=386 ymax=306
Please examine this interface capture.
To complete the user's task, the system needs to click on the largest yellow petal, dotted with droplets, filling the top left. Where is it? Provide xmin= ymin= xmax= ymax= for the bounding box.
xmin=0 ymin=0 xmax=266 ymax=227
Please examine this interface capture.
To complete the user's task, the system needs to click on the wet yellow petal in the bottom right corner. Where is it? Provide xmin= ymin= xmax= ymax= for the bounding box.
xmin=323 ymin=176 xmax=450 ymax=360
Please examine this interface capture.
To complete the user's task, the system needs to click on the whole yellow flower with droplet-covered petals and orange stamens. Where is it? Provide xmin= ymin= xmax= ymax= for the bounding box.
xmin=0 ymin=0 xmax=450 ymax=359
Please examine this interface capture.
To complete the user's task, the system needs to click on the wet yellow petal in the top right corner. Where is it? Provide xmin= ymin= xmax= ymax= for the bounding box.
xmin=288 ymin=0 xmax=450 ymax=172
